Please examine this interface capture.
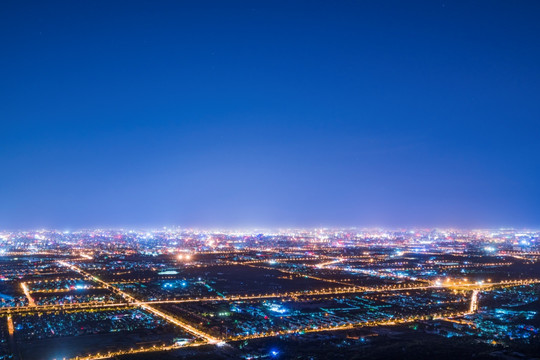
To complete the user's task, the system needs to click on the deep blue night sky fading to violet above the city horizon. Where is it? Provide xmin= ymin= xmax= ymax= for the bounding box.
xmin=0 ymin=0 xmax=540 ymax=228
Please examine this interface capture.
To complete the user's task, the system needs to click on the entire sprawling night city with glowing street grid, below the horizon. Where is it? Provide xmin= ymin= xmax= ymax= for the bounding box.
xmin=0 ymin=228 xmax=540 ymax=360
